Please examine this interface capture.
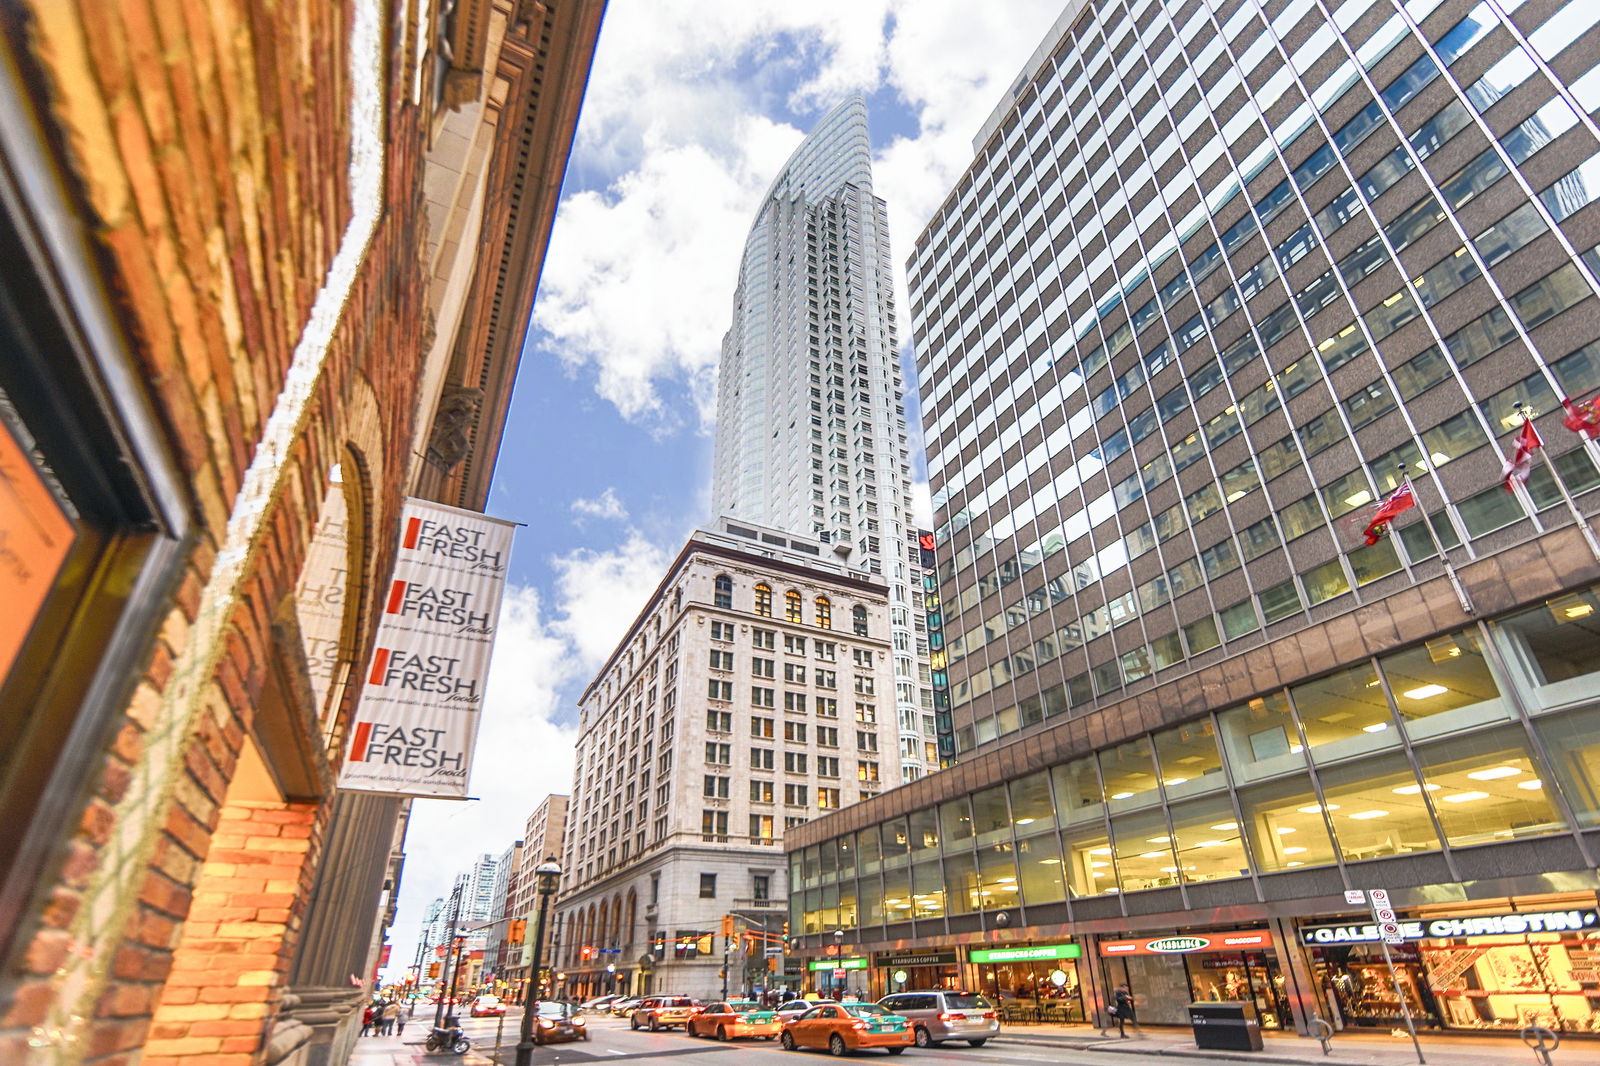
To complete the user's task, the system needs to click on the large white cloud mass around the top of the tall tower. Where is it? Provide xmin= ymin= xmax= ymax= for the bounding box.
xmin=534 ymin=0 xmax=1061 ymax=432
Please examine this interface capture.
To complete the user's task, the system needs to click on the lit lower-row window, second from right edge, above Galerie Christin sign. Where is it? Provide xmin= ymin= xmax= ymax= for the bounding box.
xmin=1416 ymin=725 xmax=1566 ymax=847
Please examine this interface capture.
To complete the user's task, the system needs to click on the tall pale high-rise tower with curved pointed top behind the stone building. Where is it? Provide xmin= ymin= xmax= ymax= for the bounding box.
xmin=712 ymin=96 xmax=938 ymax=779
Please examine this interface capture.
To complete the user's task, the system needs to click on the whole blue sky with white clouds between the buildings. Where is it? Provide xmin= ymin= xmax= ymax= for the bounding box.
xmin=380 ymin=0 xmax=1062 ymax=975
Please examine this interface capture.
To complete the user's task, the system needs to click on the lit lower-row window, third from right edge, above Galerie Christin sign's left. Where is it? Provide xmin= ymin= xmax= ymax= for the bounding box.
xmin=1320 ymin=752 xmax=1438 ymax=863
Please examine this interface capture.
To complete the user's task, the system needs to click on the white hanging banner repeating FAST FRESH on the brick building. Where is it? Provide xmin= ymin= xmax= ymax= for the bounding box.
xmin=339 ymin=499 xmax=515 ymax=787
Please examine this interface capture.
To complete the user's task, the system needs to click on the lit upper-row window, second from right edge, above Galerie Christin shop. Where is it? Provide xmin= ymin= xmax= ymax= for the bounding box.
xmin=1379 ymin=629 xmax=1509 ymax=739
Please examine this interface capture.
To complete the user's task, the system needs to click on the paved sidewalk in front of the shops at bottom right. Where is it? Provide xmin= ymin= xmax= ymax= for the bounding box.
xmin=992 ymin=1026 xmax=1568 ymax=1066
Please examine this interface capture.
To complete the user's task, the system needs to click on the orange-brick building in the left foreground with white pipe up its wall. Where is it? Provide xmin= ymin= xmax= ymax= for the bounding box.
xmin=0 ymin=0 xmax=603 ymax=1066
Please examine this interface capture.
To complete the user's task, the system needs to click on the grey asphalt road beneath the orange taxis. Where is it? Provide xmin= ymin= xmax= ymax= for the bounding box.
xmin=451 ymin=1015 xmax=1177 ymax=1066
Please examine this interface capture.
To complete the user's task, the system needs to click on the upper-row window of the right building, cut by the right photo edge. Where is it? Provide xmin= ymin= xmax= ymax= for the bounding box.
xmin=1493 ymin=589 xmax=1600 ymax=707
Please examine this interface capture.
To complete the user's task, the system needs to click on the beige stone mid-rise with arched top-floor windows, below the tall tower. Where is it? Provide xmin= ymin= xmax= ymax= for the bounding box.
xmin=555 ymin=520 xmax=899 ymax=997
